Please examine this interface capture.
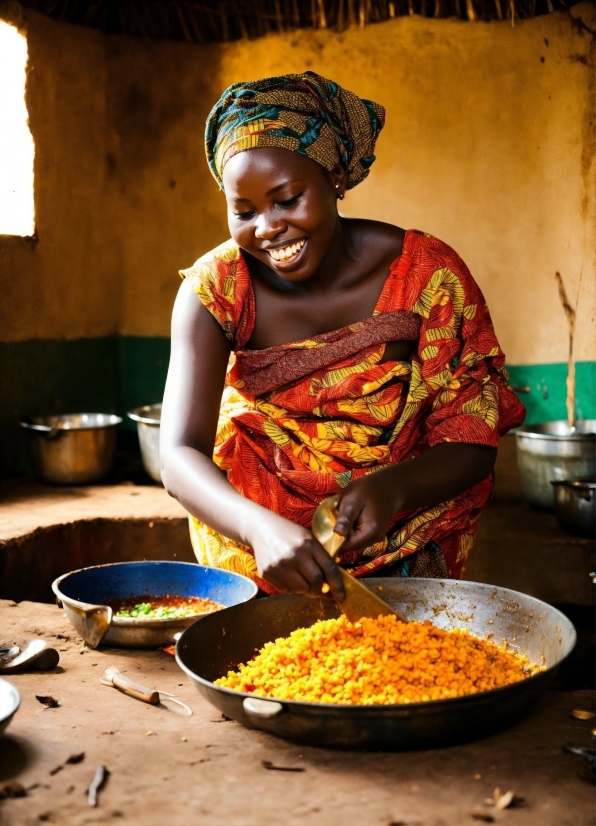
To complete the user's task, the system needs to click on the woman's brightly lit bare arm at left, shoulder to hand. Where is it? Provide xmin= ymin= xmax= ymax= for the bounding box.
xmin=160 ymin=281 xmax=344 ymax=600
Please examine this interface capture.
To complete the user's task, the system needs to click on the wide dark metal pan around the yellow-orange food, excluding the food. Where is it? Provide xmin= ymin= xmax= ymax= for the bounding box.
xmin=176 ymin=578 xmax=576 ymax=749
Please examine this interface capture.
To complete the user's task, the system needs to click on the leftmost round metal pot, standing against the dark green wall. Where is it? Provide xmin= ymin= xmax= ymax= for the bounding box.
xmin=20 ymin=413 xmax=122 ymax=485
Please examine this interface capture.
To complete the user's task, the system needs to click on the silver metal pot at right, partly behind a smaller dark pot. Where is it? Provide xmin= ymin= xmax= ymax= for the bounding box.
xmin=513 ymin=419 xmax=596 ymax=510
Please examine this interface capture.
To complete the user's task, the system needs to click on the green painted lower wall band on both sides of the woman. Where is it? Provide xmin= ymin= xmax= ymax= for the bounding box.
xmin=0 ymin=336 xmax=596 ymax=476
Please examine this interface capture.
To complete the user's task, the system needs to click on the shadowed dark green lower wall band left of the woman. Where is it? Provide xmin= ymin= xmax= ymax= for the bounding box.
xmin=0 ymin=336 xmax=170 ymax=477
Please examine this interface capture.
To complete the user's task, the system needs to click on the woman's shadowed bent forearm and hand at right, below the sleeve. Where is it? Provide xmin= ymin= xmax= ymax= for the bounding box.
xmin=335 ymin=442 xmax=497 ymax=551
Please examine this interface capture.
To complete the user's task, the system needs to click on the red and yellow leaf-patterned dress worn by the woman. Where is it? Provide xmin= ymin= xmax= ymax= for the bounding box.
xmin=181 ymin=230 xmax=525 ymax=592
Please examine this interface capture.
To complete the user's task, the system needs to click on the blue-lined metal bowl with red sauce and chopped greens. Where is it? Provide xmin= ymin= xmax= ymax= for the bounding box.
xmin=52 ymin=561 xmax=258 ymax=648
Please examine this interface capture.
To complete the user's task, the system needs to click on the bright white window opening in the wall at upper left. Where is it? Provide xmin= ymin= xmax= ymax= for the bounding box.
xmin=0 ymin=20 xmax=35 ymax=236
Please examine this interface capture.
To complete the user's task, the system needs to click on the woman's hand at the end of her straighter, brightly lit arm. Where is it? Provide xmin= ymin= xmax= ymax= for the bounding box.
xmin=250 ymin=511 xmax=345 ymax=602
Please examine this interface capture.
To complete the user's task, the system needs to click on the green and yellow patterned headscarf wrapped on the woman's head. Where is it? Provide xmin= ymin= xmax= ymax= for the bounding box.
xmin=205 ymin=72 xmax=385 ymax=189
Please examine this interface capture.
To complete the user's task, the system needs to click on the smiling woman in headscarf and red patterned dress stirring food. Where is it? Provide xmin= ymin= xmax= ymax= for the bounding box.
xmin=161 ymin=72 xmax=524 ymax=600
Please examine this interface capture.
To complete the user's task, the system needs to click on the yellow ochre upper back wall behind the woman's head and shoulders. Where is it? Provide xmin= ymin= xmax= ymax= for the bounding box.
xmin=110 ymin=4 xmax=596 ymax=364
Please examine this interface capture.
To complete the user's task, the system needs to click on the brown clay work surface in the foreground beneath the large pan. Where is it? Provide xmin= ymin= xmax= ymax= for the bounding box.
xmin=0 ymin=601 xmax=594 ymax=826
